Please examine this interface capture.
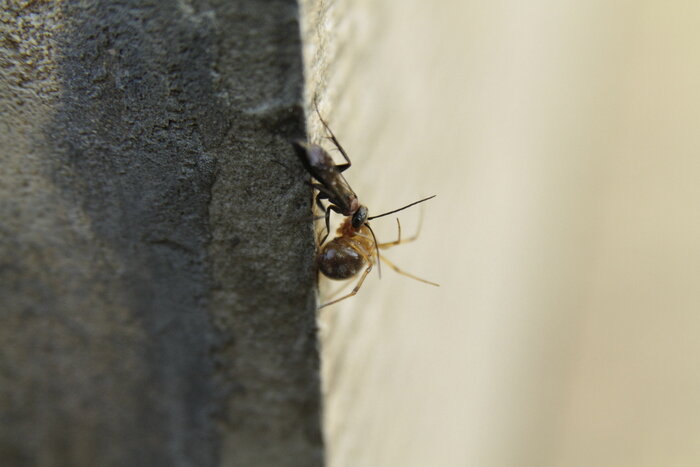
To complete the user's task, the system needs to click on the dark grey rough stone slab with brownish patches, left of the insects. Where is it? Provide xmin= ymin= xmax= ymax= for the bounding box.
xmin=0 ymin=0 xmax=322 ymax=466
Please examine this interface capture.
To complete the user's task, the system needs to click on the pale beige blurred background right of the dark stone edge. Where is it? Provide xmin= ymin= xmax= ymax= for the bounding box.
xmin=305 ymin=0 xmax=700 ymax=467
